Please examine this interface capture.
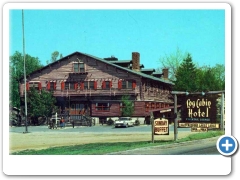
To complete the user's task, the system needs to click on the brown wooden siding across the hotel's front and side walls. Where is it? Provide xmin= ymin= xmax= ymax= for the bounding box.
xmin=19 ymin=54 xmax=173 ymax=117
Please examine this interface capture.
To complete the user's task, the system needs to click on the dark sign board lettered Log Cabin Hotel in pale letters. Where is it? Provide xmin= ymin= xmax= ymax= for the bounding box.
xmin=182 ymin=95 xmax=217 ymax=123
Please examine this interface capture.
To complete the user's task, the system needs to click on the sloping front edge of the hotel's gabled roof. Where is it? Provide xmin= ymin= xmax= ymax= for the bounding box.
xmin=21 ymin=51 xmax=174 ymax=85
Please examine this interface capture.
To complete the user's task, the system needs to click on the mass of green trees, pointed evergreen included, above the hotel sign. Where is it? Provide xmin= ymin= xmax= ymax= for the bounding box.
xmin=174 ymin=54 xmax=225 ymax=92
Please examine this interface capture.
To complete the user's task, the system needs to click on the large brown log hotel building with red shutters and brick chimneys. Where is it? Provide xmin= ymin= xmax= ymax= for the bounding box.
xmin=19 ymin=52 xmax=174 ymax=124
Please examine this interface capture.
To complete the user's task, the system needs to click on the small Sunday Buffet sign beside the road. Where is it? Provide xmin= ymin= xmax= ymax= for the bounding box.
xmin=154 ymin=119 xmax=169 ymax=135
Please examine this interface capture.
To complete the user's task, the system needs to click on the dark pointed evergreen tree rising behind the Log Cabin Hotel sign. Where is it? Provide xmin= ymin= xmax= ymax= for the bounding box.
xmin=174 ymin=53 xmax=198 ymax=91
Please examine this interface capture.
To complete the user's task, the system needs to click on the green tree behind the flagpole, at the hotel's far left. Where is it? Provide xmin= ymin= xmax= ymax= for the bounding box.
xmin=9 ymin=51 xmax=43 ymax=108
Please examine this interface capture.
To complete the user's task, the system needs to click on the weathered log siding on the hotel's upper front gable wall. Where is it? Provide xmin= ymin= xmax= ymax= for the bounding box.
xmin=20 ymin=55 xmax=141 ymax=99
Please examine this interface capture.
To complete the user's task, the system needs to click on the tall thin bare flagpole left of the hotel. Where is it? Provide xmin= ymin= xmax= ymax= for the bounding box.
xmin=22 ymin=10 xmax=28 ymax=133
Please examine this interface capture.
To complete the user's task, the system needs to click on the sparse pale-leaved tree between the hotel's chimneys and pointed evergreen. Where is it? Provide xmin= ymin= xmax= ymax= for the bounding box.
xmin=157 ymin=48 xmax=186 ymax=81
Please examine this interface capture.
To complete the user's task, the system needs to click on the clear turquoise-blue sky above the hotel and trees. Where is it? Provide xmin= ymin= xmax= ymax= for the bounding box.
xmin=9 ymin=9 xmax=225 ymax=69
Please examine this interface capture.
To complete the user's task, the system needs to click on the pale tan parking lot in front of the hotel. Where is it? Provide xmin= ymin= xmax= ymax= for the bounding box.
xmin=9 ymin=125 xmax=192 ymax=153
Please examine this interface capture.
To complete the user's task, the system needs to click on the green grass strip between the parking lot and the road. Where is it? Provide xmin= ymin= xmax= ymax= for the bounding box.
xmin=12 ymin=131 xmax=224 ymax=155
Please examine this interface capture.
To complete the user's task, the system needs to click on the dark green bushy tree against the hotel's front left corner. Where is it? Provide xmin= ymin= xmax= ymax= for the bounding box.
xmin=27 ymin=88 xmax=56 ymax=118
